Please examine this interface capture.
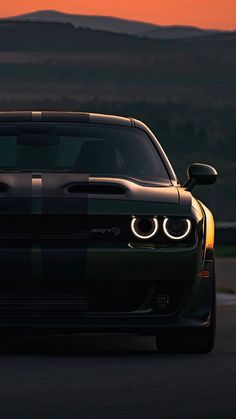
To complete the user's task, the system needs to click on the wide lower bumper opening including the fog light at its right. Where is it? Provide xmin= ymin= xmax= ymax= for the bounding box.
xmin=0 ymin=280 xmax=186 ymax=323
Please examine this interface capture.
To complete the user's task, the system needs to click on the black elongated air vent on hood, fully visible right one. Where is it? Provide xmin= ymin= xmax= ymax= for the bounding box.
xmin=67 ymin=183 xmax=126 ymax=195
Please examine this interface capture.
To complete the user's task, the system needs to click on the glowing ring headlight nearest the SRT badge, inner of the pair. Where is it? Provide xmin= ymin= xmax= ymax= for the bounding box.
xmin=131 ymin=217 xmax=158 ymax=240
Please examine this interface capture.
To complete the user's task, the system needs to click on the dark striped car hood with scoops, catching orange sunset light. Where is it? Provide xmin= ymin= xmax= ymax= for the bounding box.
xmin=0 ymin=173 xmax=191 ymax=212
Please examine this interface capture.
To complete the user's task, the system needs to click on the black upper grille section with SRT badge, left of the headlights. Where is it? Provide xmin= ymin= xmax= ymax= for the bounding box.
xmin=0 ymin=214 xmax=131 ymax=242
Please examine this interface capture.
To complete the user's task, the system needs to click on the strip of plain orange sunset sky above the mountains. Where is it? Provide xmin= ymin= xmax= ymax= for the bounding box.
xmin=0 ymin=0 xmax=236 ymax=29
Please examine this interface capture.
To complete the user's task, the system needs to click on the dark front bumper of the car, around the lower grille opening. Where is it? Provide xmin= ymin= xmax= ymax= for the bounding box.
xmin=0 ymin=245 xmax=214 ymax=333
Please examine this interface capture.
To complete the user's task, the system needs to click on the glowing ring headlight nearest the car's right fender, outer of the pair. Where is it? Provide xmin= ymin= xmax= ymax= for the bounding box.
xmin=163 ymin=218 xmax=192 ymax=240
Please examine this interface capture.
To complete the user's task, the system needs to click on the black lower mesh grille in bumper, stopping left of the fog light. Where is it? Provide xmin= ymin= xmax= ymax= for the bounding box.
xmin=0 ymin=283 xmax=148 ymax=320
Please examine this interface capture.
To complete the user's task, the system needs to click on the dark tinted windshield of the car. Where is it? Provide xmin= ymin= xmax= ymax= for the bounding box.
xmin=0 ymin=123 xmax=169 ymax=180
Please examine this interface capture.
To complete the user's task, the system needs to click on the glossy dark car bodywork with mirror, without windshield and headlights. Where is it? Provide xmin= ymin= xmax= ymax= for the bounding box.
xmin=0 ymin=112 xmax=216 ymax=342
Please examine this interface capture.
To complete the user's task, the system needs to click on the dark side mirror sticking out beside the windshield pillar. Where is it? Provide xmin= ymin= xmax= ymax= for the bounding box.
xmin=184 ymin=163 xmax=217 ymax=191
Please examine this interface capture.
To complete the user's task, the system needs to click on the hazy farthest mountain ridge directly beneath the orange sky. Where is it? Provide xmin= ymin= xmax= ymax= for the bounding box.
xmin=4 ymin=10 xmax=227 ymax=39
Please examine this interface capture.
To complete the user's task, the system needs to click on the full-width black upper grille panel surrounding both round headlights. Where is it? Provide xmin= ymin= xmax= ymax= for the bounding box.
xmin=0 ymin=214 xmax=195 ymax=248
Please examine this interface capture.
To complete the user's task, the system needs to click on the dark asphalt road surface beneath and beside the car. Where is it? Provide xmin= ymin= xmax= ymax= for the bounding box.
xmin=0 ymin=260 xmax=236 ymax=419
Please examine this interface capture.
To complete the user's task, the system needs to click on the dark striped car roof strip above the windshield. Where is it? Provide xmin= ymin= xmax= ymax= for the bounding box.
xmin=0 ymin=111 xmax=135 ymax=126
